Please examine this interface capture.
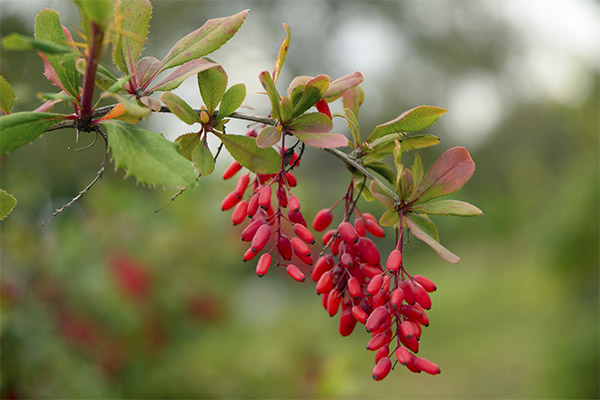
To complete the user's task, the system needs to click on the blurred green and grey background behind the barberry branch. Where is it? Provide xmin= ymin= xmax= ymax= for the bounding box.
xmin=0 ymin=0 xmax=600 ymax=399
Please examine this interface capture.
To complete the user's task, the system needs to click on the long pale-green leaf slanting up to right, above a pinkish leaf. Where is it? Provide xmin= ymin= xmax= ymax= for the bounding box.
xmin=160 ymin=10 xmax=248 ymax=71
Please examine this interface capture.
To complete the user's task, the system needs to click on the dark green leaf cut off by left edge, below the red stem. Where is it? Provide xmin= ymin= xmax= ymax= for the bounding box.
xmin=0 ymin=112 xmax=64 ymax=156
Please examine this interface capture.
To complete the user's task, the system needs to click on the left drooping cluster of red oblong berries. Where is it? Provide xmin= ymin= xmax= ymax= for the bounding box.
xmin=221 ymin=130 xmax=315 ymax=282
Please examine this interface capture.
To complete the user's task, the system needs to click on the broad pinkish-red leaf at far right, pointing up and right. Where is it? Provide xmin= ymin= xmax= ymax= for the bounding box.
xmin=413 ymin=147 xmax=475 ymax=202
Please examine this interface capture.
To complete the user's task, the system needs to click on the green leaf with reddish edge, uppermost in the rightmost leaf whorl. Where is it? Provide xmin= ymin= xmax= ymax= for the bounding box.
xmin=367 ymin=106 xmax=448 ymax=142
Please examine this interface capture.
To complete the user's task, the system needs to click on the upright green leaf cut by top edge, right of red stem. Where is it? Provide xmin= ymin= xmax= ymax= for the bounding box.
xmin=112 ymin=0 xmax=152 ymax=73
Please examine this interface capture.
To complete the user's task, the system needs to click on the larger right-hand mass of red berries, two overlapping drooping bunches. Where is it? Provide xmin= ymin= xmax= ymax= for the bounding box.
xmin=311 ymin=184 xmax=440 ymax=380
